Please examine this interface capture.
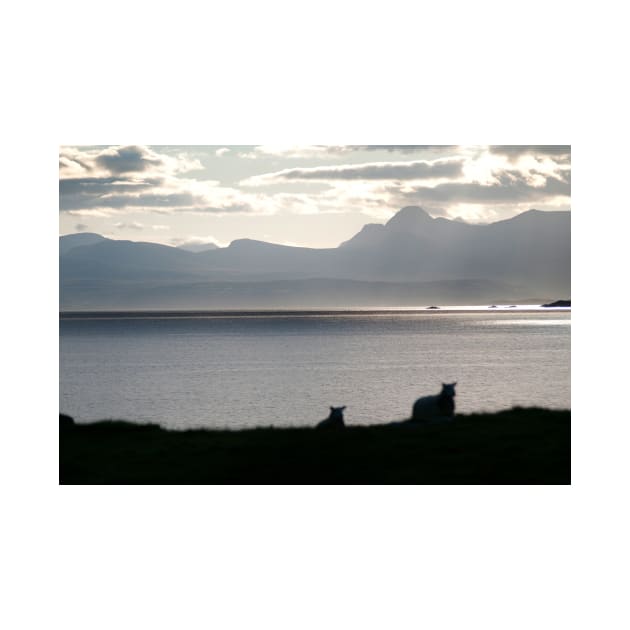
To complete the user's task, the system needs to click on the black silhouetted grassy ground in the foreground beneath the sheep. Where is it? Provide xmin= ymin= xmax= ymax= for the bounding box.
xmin=59 ymin=408 xmax=571 ymax=484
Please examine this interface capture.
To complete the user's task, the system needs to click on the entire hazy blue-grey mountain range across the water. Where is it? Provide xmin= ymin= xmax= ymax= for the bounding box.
xmin=59 ymin=206 xmax=571 ymax=310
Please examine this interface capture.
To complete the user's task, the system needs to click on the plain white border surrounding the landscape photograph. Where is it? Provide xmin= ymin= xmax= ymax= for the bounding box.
xmin=2 ymin=1 xmax=628 ymax=630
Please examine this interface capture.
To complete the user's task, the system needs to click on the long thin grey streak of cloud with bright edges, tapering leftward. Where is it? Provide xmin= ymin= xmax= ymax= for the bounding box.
xmin=241 ymin=160 xmax=463 ymax=186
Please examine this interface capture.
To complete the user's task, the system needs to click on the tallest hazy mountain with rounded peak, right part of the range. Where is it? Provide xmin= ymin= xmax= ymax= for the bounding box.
xmin=340 ymin=207 xmax=571 ymax=291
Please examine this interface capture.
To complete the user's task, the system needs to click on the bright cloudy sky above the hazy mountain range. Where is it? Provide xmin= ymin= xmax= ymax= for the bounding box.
xmin=59 ymin=145 xmax=571 ymax=247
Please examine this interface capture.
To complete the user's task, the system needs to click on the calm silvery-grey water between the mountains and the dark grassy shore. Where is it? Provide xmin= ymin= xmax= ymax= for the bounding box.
xmin=59 ymin=310 xmax=571 ymax=428
